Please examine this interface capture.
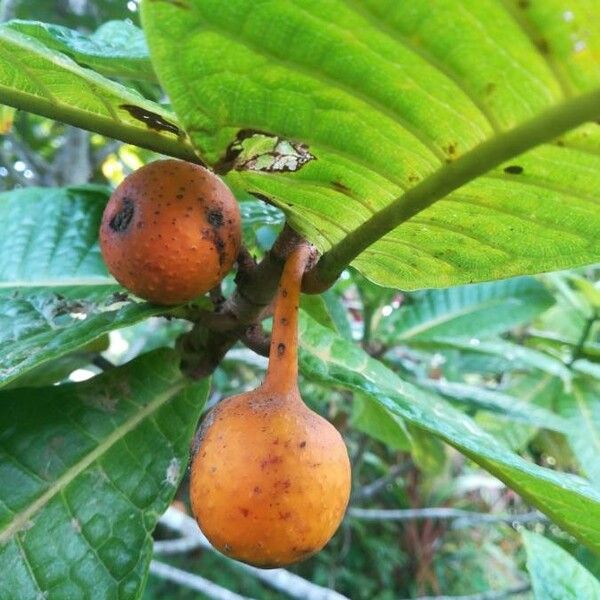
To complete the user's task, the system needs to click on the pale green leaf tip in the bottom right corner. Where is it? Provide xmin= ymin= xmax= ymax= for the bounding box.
xmin=522 ymin=530 xmax=600 ymax=600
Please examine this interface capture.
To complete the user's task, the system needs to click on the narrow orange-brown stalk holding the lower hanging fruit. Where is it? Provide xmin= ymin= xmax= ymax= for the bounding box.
xmin=263 ymin=244 xmax=311 ymax=394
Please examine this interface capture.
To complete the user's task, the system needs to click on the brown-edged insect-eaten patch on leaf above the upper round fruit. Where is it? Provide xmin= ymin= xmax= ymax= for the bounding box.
xmin=215 ymin=129 xmax=316 ymax=173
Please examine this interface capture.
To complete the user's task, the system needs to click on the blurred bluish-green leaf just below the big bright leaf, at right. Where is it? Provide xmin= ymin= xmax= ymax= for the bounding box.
xmin=378 ymin=277 xmax=554 ymax=343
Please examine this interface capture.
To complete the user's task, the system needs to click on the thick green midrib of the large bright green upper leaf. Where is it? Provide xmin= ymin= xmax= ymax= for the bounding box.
xmin=314 ymin=89 xmax=600 ymax=287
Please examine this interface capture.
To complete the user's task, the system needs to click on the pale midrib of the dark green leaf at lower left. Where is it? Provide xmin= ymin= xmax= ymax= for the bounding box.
xmin=0 ymin=383 xmax=184 ymax=544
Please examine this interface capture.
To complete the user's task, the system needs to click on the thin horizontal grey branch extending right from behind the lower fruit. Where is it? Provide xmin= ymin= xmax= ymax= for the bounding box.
xmin=348 ymin=507 xmax=548 ymax=529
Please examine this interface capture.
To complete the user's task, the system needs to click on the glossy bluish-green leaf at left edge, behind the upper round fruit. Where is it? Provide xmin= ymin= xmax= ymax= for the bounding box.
xmin=0 ymin=186 xmax=163 ymax=386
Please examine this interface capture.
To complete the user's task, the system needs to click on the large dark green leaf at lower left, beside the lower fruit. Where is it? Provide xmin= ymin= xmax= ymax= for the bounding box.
xmin=0 ymin=351 xmax=208 ymax=600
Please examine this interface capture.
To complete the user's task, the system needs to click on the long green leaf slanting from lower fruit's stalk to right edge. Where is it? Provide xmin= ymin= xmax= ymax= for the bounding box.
xmin=300 ymin=315 xmax=600 ymax=551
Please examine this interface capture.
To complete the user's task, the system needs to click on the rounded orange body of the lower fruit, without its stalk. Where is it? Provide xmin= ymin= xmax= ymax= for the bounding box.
xmin=190 ymin=388 xmax=350 ymax=567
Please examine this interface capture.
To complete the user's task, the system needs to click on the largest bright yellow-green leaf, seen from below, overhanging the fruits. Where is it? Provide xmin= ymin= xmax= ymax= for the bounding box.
xmin=142 ymin=0 xmax=600 ymax=289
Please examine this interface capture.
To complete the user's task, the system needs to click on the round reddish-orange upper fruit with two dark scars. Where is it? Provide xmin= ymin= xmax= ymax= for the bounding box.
xmin=100 ymin=159 xmax=242 ymax=305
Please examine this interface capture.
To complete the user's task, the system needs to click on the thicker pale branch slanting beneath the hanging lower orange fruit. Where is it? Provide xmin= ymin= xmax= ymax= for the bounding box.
xmin=155 ymin=507 xmax=348 ymax=600
